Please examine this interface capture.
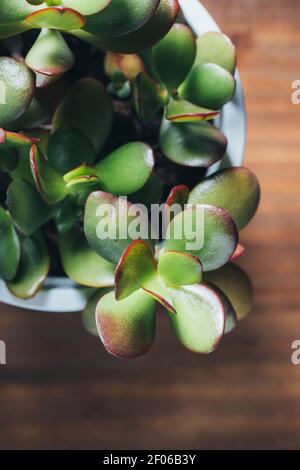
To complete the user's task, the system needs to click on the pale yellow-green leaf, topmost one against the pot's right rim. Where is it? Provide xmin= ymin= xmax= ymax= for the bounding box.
xmin=195 ymin=31 xmax=236 ymax=74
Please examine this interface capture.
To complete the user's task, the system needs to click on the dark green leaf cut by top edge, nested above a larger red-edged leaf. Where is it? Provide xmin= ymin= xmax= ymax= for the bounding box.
xmin=84 ymin=0 xmax=159 ymax=38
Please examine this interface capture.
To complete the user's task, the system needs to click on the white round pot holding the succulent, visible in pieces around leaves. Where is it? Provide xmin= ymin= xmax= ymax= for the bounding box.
xmin=0 ymin=0 xmax=246 ymax=313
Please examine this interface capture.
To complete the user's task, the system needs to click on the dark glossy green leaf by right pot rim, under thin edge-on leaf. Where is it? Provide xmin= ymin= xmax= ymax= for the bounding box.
xmin=160 ymin=120 xmax=227 ymax=168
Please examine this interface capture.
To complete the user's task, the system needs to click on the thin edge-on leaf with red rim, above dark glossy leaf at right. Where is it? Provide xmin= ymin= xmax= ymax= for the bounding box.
xmin=166 ymin=99 xmax=219 ymax=122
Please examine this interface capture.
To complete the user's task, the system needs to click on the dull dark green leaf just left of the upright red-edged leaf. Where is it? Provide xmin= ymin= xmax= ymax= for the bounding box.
xmin=6 ymin=179 xmax=53 ymax=236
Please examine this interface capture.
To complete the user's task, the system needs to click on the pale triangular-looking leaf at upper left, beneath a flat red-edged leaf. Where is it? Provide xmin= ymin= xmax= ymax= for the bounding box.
xmin=25 ymin=29 xmax=75 ymax=75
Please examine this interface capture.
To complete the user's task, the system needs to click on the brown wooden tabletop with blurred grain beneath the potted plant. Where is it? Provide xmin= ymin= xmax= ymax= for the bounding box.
xmin=0 ymin=0 xmax=300 ymax=449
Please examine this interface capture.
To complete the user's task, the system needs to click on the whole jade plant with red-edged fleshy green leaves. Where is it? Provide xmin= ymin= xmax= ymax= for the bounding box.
xmin=0 ymin=0 xmax=259 ymax=358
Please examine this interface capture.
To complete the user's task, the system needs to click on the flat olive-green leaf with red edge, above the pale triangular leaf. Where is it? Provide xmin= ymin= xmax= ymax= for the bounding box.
xmin=25 ymin=6 xmax=85 ymax=31
